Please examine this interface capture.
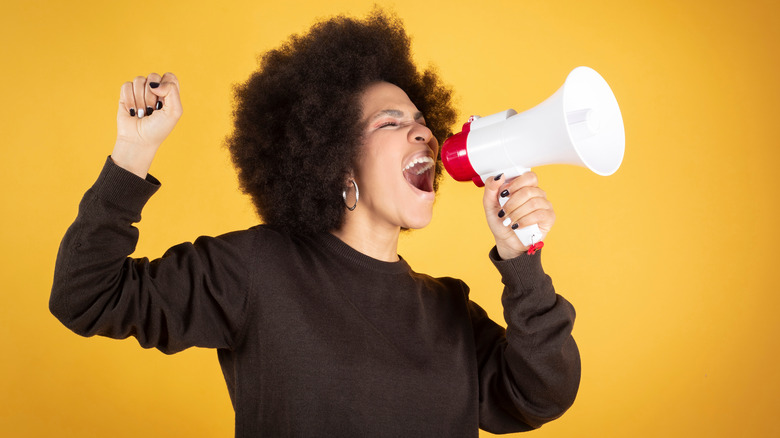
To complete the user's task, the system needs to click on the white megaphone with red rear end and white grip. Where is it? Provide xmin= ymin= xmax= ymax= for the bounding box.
xmin=441 ymin=67 xmax=626 ymax=247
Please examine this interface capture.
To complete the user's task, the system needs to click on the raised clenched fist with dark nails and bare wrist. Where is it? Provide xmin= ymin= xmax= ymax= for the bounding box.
xmin=111 ymin=73 xmax=182 ymax=178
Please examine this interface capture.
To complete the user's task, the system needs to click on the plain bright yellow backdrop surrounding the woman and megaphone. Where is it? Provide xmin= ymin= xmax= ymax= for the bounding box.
xmin=0 ymin=0 xmax=780 ymax=437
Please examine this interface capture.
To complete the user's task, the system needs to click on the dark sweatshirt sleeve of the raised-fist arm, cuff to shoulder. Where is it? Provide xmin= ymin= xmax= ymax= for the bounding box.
xmin=49 ymin=157 xmax=249 ymax=354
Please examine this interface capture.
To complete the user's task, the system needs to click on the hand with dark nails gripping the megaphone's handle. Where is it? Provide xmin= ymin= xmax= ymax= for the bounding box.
xmin=482 ymin=172 xmax=555 ymax=260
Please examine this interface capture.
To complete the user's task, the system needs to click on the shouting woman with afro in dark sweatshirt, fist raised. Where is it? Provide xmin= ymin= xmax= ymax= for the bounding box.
xmin=50 ymin=8 xmax=580 ymax=437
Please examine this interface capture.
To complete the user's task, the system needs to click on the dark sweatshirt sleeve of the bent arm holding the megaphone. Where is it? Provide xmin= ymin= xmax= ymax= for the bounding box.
xmin=470 ymin=248 xmax=580 ymax=433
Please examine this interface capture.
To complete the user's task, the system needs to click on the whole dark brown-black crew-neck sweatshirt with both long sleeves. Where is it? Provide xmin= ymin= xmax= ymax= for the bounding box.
xmin=50 ymin=159 xmax=580 ymax=437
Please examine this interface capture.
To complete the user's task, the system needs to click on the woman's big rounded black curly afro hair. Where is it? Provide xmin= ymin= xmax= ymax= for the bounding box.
xmin=227 ymin=9 xmax=456 ymax=234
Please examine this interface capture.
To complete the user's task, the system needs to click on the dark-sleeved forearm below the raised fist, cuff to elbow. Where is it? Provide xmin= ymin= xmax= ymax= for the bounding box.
xmin=49 ymin=158 xmax=159 ymax=337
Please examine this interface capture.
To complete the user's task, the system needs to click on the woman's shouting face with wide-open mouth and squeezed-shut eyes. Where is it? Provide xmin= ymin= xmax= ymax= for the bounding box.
xmin=350 ymin=82 xmax=439 ymax=233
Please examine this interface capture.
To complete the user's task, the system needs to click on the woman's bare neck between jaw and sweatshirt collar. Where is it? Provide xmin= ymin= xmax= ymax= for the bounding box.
xmin=331 ymin=218 xmax=401 ymax=262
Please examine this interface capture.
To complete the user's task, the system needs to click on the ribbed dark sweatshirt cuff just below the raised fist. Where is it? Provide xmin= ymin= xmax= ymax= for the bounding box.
xmin=93 ymin=156 xmax=161 ymax=214
